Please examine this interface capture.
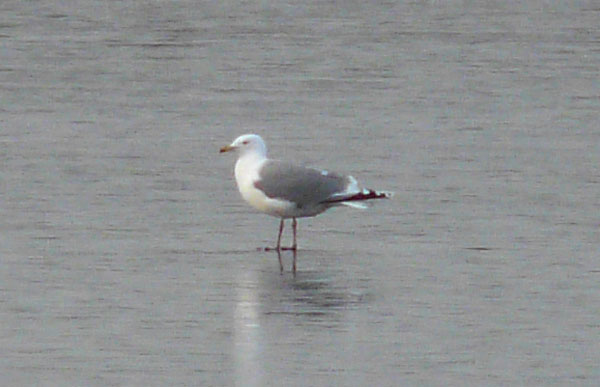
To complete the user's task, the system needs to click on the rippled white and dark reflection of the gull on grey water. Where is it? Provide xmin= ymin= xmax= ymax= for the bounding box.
xmin=232 ymin=252 xmax=369 ymax=385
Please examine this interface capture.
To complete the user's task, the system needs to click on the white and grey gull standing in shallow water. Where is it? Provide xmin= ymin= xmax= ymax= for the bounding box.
xmin=220 ymin=134 xmax=392 ymax=252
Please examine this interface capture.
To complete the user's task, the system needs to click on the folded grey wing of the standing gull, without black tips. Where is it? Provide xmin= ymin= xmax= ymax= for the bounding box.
xmin=254 ymin=160 xmax=351 ymax=207
